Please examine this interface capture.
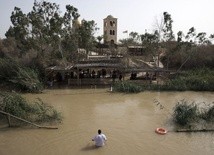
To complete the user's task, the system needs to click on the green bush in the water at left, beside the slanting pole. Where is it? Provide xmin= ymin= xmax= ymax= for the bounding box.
xmin=0 ymin=93 xmax=62 ymax=123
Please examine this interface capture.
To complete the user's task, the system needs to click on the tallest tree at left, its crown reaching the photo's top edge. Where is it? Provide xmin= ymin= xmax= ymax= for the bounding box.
xmin=28 ymin=1 xmax=66 ymax=57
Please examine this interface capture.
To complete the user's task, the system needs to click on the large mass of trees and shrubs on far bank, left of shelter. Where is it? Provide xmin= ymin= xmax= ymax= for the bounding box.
xmin=0 ymin=1 xmax=97 ymax=92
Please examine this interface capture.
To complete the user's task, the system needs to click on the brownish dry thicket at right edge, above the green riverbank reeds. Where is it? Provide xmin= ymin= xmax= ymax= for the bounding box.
xmin=161 ymin=42 xmax=214 ymax=71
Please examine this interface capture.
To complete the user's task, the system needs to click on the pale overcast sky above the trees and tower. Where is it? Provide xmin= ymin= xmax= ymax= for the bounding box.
xmin=0 ymin=0 xmax=214 ymax=39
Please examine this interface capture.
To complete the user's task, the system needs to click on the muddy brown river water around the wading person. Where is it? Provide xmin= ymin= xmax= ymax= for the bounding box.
xmin=0 ymin=89 xmax=214 ymax=155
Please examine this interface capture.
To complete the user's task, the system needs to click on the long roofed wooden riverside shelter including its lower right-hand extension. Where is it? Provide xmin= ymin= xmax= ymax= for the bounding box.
xmin=46 ymin=58 xmax=174 ymax=86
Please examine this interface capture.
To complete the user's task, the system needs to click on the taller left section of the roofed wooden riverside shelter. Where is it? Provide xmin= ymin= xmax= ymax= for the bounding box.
xmin=46 ymin=59 xmax=125 ymax=86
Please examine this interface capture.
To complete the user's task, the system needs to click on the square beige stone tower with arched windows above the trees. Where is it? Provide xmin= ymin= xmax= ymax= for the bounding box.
xmin=103 ymin=15 xmax=117 ymax=44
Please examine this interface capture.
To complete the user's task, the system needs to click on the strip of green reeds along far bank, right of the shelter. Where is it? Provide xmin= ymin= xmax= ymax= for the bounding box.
xmin=114 ymin=68 xmax=214 ymax=93
